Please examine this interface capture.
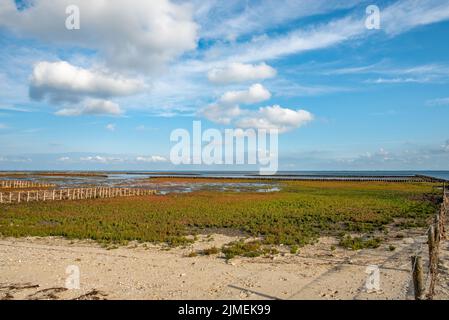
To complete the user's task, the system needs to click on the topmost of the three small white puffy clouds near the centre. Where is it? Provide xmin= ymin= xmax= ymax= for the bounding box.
xmin=207 ymin=62 xmax=276 ymax=84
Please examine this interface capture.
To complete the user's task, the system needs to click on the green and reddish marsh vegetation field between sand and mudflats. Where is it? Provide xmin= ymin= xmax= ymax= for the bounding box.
xmin=0 ymin=180 xmax=441 ymax=258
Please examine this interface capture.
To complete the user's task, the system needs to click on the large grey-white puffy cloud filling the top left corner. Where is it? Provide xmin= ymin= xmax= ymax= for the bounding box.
xmin=0 ymin=0 xmax=198 ymax=72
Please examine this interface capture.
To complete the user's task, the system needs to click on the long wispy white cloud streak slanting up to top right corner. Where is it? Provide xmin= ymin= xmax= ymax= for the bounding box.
xmin=192 ymin=0 xmax=449 ymax=69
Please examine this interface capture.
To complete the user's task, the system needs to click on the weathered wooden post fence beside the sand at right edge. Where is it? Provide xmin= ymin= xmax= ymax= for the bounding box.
xmin=412 ymin=185 xmax=449 ymax=300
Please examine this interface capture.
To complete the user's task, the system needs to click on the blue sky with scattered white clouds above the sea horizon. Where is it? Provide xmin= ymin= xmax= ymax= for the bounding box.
xmin=0 ymin=0 xmax=449 ymax=170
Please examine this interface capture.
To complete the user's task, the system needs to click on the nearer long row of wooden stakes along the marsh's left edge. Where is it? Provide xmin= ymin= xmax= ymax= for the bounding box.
xmin=0 ymin=187 xmax=156 ymax=204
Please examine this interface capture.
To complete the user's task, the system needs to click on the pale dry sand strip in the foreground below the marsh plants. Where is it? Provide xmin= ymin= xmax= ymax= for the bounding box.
xmin=0 ymin=228 xmax=449 ymax=299
